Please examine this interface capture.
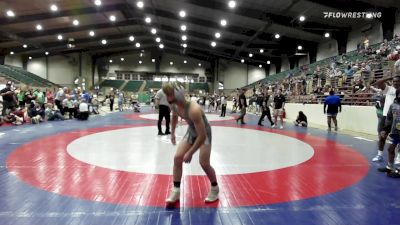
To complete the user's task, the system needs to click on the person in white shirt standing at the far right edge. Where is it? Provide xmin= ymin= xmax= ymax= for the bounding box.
xmin=372 ymin=76 xmax=400 ymax=163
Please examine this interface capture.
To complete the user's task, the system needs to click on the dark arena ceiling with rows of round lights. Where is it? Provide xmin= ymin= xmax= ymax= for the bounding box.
xmin=0 ymin=0 xmax=400 ymax=66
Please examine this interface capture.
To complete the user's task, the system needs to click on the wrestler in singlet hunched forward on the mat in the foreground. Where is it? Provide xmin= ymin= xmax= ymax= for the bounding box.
xmin=162 ymin=83 xmax=219 ymax=204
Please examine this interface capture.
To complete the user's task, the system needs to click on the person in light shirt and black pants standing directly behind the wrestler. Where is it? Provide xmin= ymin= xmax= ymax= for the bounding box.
xmin=155 ymin=89 xmax=171 ymax=135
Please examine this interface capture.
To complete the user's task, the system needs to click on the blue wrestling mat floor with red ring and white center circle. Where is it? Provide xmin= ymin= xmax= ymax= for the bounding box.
xmin=0 ymin=109 xmax=400 ymax=225
